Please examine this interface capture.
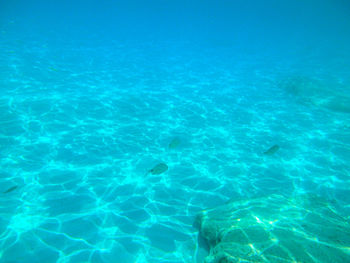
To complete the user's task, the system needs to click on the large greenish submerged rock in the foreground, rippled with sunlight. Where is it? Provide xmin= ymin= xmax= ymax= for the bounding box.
xmin=196 ymin=194 xmax=350 ymax=263
